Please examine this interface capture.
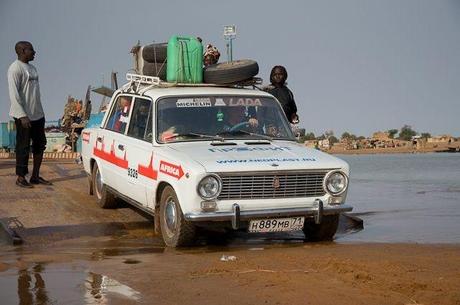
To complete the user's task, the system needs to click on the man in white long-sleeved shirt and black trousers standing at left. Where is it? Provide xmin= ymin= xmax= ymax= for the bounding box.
xmin=8 ymin=41 xmax=51 ymax=188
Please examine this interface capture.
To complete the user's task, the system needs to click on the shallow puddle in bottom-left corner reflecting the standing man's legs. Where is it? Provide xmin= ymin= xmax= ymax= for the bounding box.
xmin=5 ymin=263 xmax=141 ymax=305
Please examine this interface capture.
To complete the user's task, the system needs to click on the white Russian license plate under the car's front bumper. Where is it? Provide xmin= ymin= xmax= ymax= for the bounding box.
xmin=248 ymin=217 xmax=305 ymax=233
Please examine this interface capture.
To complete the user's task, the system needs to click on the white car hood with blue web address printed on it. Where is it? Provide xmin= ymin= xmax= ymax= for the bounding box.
xmin=169 ymin=141 xmax=348 ymax=173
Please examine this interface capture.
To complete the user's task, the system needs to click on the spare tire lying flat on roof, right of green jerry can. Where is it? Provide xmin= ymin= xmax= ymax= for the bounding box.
xmin=203 ymin=59 xmax=259 ymax=84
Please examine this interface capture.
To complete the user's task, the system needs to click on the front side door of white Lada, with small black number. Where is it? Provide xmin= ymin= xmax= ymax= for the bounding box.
xmin=120 ymin=97 xmax=157 ymax=208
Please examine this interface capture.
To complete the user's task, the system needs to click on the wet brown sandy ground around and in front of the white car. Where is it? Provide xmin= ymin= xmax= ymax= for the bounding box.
xmin=0 ymin=161 xmax=460 ymax=305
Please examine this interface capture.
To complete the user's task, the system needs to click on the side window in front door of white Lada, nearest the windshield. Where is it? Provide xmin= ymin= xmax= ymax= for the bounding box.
xmin=128 ymin=98 xmax=152 ymax=142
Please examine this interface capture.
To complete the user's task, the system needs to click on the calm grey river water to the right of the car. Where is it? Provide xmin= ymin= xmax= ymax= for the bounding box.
xmin=337 ymin=153 xmax=460 ymax=243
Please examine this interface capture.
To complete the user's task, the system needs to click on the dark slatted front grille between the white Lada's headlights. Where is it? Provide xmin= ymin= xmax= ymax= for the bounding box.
xmin=218 ymin=171 xmax=327 ymax=200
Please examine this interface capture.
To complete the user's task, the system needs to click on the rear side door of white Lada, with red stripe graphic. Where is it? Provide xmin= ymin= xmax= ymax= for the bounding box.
xmin=93 ymin=95 xmax=133 ymax=193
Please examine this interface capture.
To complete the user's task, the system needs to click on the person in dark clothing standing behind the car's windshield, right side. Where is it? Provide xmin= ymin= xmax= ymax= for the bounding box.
xmin=267 ymin=66 xmax=299 ymax=124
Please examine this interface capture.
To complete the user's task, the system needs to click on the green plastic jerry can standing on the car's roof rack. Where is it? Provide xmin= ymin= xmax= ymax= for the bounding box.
xmin=166 ymin=35 xmax=203 ymax=84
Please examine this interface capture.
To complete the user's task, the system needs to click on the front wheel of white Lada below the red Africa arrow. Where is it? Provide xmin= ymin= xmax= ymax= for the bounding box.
xmin=160 ymin=186 xmax=196 ymax=248
